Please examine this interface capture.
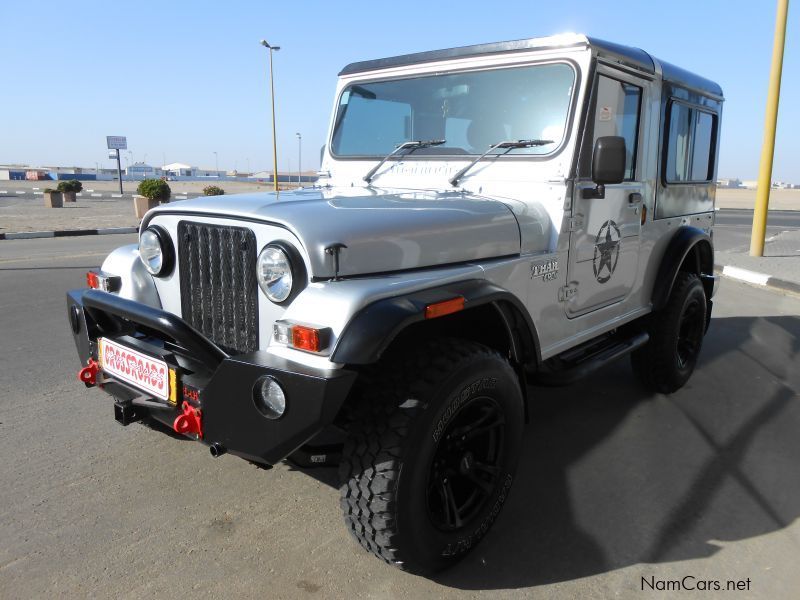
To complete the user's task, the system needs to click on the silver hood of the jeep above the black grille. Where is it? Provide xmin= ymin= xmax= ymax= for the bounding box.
xmin=145 ymin=188 xmax=520 ymax=278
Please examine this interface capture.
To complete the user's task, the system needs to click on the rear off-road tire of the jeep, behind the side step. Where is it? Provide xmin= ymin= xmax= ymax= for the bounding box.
xmin=631 ymin=271 xmax=708 ymax=394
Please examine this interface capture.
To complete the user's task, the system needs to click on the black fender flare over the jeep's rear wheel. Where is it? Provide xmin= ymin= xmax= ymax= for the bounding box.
xmin=652 ymin=225 xmax=714 ymax=311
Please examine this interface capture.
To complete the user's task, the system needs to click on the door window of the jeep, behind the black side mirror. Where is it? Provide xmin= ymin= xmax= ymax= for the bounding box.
xmin=592 ymin=75 xmax=642 ymax=180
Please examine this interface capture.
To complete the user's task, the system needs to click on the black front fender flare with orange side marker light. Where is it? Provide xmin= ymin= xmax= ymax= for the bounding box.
xmin=331 ymin=279 xmax=541 ymax=365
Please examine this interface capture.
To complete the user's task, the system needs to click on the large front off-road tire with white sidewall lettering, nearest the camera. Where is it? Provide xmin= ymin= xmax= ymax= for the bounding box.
xmin=339 ymin=339 xmax=524 ymax=574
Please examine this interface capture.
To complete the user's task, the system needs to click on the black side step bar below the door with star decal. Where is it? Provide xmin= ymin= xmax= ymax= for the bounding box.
xmin=531 ymin=332 xmax=650 ymax=386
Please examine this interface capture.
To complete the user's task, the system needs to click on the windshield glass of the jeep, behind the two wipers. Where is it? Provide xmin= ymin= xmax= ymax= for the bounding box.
xmin=331 ymin=63 xmax=575 ymax=158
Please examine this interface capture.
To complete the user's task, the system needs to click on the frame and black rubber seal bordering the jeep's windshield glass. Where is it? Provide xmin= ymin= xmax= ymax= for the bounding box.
xmin=325 ymin=57 xmax=583 ymax=162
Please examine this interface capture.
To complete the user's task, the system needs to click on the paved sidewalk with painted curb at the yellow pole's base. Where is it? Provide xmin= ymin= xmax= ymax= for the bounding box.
xmin=715 ymin=229 xmax=800 ymax=293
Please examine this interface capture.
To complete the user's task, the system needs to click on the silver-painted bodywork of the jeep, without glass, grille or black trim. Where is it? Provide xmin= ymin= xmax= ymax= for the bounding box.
xmin=98 ymin=36 xmax=714 ymax=368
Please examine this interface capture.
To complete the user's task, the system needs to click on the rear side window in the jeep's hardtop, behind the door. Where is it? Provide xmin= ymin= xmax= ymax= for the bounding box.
xmin=664 ymin=102 xmax=717 ymax=183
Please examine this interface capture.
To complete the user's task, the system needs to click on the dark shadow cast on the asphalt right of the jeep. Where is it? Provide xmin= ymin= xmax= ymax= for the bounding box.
xmin=435 ymin=317 xmax=800 ymax=590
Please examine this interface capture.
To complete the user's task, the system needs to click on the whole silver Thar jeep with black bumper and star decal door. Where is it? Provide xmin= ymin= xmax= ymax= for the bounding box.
xmin=68 ymin=35 xmax=723 ymax=573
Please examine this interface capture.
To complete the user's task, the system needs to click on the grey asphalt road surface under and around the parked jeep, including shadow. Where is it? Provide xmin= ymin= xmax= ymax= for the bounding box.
xmin=0 ymin=236 xmax=800 ymax=600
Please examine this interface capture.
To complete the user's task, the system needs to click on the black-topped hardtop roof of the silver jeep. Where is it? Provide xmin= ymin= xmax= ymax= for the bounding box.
xmin=339 ymin=36 xmax=722 ymax=97
